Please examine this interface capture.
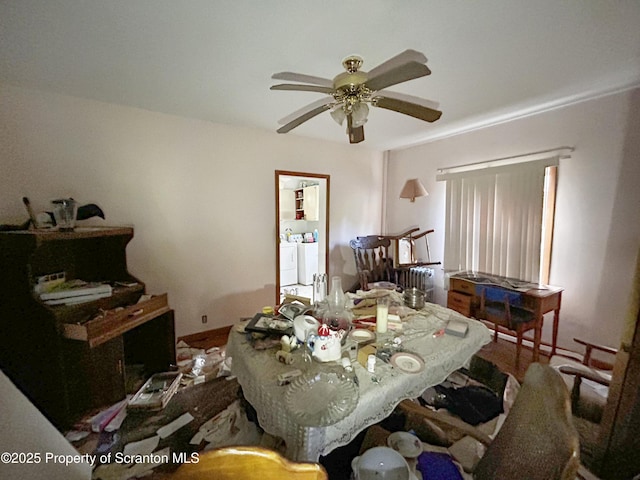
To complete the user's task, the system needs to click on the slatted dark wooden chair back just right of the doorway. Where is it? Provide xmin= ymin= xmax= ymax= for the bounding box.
xmin=349 ymin=235 xmax=397 ymax=290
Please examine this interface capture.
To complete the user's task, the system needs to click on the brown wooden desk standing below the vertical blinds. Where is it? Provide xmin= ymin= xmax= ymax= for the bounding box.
xmin=447 ymin=272 xmax=563 ymax=362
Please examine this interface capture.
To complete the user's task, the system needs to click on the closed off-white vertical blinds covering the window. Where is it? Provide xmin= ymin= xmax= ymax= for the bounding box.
xmin=438 ymin=157 xmax=558 ymax=283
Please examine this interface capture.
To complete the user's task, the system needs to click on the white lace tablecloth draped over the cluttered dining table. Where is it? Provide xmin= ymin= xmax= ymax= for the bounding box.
xmin=226 ymin=303 xmax=491 ymax=462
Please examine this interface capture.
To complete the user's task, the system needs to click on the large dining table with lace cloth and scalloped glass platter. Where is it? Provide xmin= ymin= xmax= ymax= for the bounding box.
xmin=227 ymin=292 xmax=490 ymax=462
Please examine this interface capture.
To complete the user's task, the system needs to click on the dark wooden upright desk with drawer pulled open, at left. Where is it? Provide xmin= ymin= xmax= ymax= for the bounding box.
xmin=0 ymin=227 xmax=175 ymax=429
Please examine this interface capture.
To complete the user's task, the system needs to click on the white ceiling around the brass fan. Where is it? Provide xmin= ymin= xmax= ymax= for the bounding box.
xmin=0 ymin=0 xmax=640 ymax=150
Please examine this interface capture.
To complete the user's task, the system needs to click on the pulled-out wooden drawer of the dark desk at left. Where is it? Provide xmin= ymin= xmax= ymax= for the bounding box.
xmin=62 ymin=293 xmax=171 ymax=348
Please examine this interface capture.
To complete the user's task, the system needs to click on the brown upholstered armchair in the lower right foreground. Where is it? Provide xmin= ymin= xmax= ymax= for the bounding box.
xmin=399 ymin=363 xmax=580 ymax=480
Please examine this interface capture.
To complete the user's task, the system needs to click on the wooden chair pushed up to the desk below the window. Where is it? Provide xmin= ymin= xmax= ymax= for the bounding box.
xmin=477 ymin=287 xmax=537 ymax=370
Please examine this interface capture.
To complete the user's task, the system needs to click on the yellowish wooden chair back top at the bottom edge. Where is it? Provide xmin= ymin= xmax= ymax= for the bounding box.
xmin=170 ymin=447 xmax=329 ymax=480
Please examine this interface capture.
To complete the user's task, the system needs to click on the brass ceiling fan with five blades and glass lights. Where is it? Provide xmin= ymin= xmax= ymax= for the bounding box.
xmin=271 ymin=50 xmax=442 ymax=143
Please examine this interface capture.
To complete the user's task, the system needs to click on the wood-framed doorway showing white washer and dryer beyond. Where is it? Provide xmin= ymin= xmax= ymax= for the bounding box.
xmin=275 ymin=170 xmax=330 ymax=305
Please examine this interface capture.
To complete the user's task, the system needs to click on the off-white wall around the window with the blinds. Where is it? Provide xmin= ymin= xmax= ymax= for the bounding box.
xmin=386 ymin=90 xmax=640 ymax=346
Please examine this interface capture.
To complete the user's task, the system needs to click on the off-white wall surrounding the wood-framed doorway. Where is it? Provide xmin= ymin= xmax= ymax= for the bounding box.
xmin=0 ymin=85 xmax=383 ymax=335
